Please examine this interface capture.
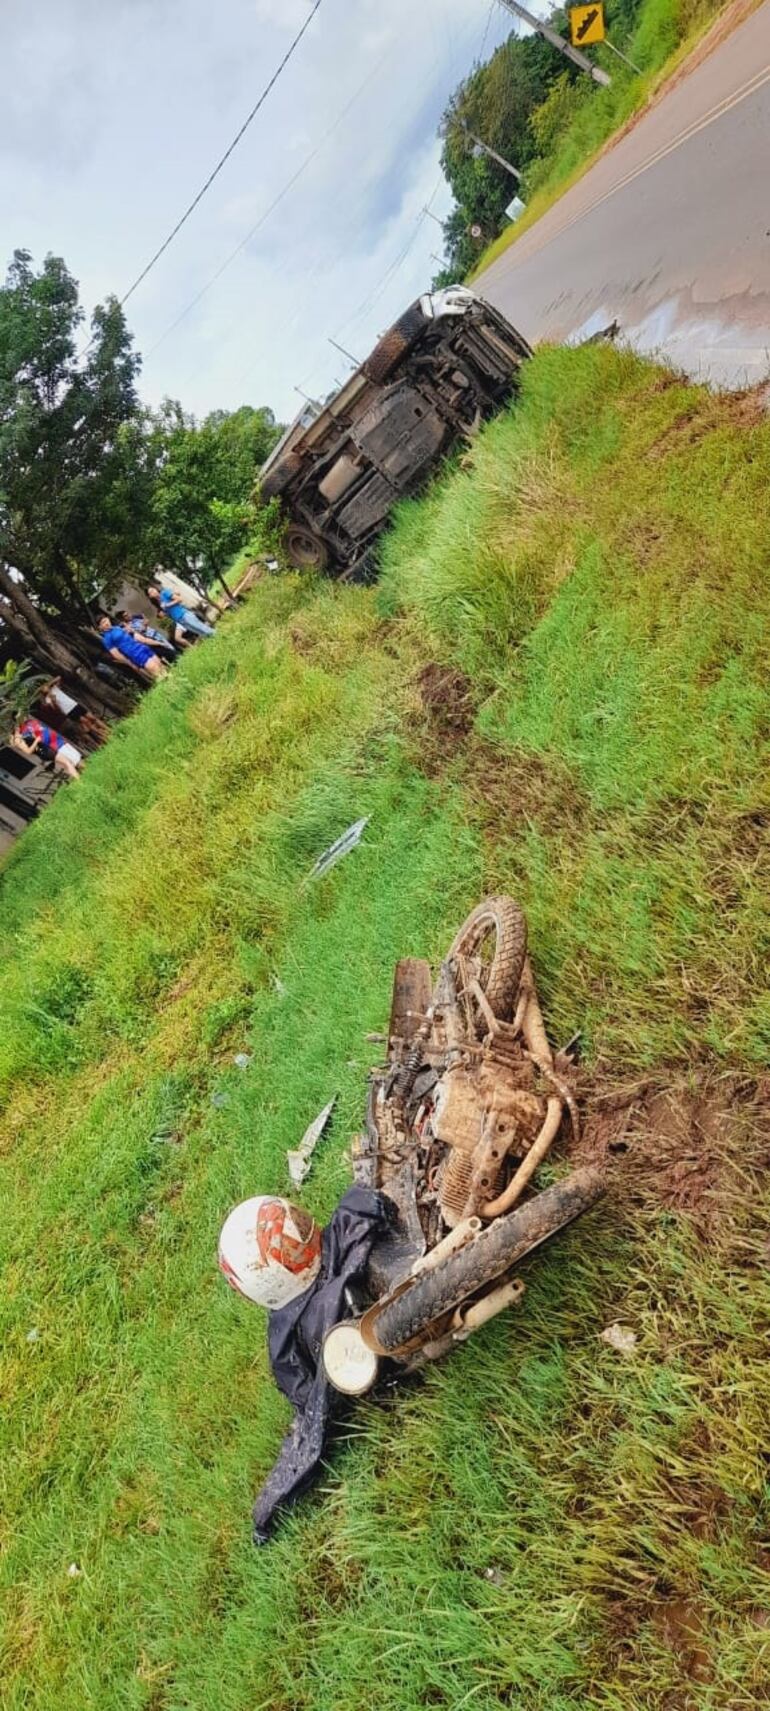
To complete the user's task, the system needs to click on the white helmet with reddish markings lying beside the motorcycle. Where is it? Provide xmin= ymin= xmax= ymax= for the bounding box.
xmin=219 ymin=1194 xmax=322 ymax=1309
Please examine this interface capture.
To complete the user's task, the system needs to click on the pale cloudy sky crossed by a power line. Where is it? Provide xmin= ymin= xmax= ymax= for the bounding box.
xmin=0 ymin=0 xmax=523 ymax=421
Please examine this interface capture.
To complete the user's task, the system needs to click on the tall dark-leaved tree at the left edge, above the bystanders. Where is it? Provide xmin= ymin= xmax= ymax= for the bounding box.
xmin=0 ymin=250 xmax=147 ymax=708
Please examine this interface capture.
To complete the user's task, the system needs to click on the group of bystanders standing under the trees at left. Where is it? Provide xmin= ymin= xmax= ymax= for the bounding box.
xmin=12 ymin=573 xmax=220 ymax=779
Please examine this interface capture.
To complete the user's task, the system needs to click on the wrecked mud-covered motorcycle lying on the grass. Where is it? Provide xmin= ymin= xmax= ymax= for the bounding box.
xmin=323 ymin=897 xmax=604 ymax=1394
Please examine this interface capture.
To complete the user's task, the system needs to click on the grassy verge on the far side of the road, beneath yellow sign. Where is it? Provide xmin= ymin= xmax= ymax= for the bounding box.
xmin=469 ymin=0 xmax=758 ymax=282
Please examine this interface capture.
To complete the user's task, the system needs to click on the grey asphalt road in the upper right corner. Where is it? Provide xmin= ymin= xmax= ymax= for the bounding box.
xmin=476 ymin=0 xmax=770 ymax=387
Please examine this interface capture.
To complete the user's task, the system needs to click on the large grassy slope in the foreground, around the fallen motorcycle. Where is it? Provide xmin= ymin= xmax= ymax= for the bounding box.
xmin=0 ymin=347 xmax=770 ymax=1711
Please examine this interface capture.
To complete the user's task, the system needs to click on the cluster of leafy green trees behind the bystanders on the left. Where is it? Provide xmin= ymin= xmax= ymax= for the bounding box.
xmin=0 ymin=250 xmax=281 ymax=707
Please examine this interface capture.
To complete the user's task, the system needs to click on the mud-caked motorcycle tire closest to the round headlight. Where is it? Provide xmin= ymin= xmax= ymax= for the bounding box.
xmin=370 ymin=1167 xmax=604 ymax=1355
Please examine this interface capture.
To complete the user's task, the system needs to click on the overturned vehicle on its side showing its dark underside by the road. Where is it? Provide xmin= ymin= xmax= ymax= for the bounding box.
xmin=260 ymin=286 xmax=532 ymax=577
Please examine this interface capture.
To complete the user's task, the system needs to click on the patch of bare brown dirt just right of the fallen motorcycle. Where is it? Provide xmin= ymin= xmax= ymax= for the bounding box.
xmin=572 ymin=1075 xmax=770 ymax=1239
